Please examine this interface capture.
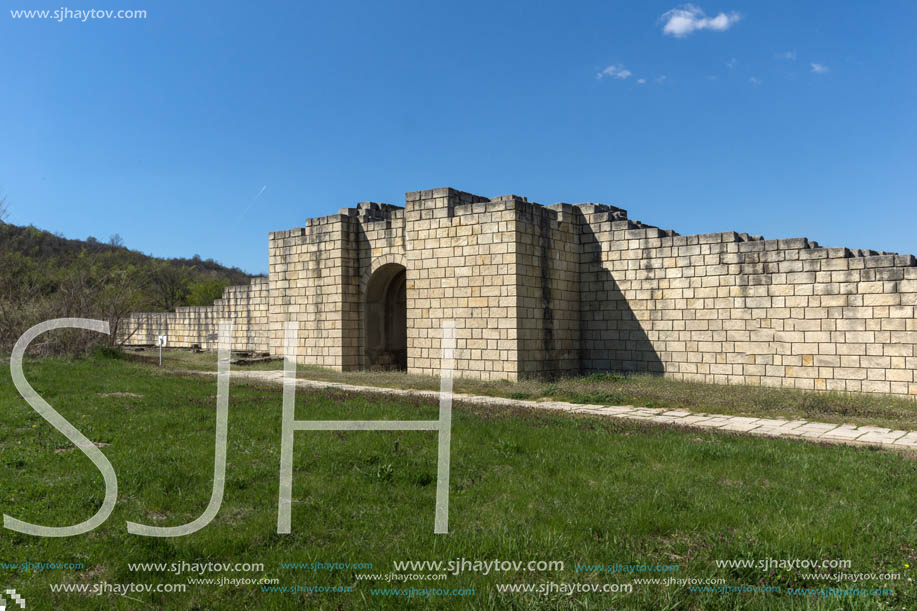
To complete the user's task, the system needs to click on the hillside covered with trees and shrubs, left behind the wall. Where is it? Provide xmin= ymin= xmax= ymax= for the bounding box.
xmin=0 ymin=215 xmax=260 ymax=355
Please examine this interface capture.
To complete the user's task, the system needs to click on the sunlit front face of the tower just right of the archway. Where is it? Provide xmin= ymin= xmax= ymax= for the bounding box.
xmin=404 ymin=188 xmax=519 ymax=380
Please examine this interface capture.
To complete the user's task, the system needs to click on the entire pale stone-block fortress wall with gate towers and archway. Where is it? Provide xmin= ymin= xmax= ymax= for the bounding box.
xmin=121 ymin=188 xmax=917 ymax=395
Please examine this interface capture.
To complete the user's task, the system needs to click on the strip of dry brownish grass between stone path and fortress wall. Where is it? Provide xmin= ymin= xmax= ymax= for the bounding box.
xmin=130 ymin=350 xmax=917 ymax=430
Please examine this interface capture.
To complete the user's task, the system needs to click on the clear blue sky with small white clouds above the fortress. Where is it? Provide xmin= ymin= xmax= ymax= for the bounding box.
xmin=0 ymin=0 xmax=917 ymax=272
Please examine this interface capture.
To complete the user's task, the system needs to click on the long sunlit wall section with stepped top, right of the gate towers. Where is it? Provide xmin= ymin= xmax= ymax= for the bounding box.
xmin=584 ymin=215 xmax=917 ymax=394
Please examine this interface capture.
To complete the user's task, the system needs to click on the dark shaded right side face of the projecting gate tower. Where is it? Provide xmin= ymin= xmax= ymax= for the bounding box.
xmin=509 ymin=201 xmax=582 ymax=377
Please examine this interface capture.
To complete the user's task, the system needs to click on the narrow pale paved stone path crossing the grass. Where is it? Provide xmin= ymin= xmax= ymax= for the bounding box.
xmin=210 ymin=371 xmax=917 ymax=450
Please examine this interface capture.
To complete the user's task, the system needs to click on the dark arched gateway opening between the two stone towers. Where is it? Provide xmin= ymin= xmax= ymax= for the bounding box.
xmin=366 ymin=263 xmax=408 ymax=370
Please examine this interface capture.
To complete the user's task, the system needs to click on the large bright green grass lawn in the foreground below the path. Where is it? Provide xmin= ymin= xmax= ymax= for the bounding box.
xmin=0 ymin=353 xmax=917 ymax=610
